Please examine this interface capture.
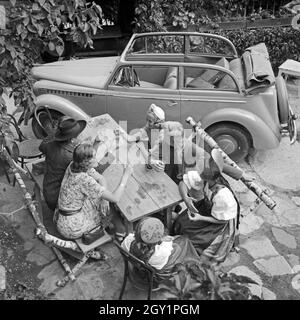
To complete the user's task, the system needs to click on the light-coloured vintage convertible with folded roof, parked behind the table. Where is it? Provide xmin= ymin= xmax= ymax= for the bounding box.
xmin=32 ymin=32 xmax=297 ymax=160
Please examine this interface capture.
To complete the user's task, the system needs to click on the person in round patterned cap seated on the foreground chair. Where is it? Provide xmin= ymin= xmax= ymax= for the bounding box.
xmin=121 ymin=217 xmax=200 ymax=272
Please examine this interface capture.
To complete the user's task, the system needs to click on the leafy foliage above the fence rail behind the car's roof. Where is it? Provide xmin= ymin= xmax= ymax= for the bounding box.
xmin=136 ymin=0 xmax=288 ymax=31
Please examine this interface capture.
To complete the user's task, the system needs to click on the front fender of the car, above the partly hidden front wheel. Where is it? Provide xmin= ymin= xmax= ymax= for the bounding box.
xmin=35 ymin=94 xmax=90 ymax=120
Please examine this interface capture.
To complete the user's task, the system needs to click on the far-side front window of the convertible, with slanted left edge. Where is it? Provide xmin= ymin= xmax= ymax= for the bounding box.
xmin=128 ymin=35 xmax=184 ymax=54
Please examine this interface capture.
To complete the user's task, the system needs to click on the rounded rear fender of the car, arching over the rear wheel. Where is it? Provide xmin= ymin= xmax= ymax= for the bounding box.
xmin=200 ymin=108 xmax=280 ymax=150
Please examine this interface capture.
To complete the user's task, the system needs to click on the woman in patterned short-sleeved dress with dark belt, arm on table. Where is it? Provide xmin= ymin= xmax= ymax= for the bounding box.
xmin=55 ymin=143 xmax=132 ymax=240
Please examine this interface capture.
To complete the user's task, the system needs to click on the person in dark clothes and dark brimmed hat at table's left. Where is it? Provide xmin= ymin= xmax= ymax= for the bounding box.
xmin=39 ymin=116 xmax=86 ymax=211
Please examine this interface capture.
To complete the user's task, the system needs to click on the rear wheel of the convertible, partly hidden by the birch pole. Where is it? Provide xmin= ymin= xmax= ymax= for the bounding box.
xmin=206 ymin=123 xmax=251 ymax=162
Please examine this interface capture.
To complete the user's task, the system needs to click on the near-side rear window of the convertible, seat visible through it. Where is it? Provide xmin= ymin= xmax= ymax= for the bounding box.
xmin=183 ymin=67 xmax=238 ymax=91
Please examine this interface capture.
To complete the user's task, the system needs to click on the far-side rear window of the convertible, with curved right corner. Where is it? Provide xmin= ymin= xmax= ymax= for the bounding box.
xmin=188 ymin=35 xmax=234 ymax=56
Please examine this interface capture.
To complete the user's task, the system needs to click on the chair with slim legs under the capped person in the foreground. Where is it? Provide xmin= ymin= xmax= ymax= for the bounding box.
xmin=114 ymin=241 xmax=175 ymax=300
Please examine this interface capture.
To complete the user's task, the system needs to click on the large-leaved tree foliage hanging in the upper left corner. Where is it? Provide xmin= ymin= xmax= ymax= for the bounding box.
xmin=0 ymin=0 xmax=102 ymax=119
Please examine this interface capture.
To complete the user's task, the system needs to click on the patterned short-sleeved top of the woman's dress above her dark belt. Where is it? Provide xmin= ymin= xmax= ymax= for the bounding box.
xmin=58 ymin=163 xmax=105 ymax=211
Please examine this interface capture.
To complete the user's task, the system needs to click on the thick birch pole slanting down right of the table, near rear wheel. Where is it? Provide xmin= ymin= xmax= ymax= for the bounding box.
xmin=186 ymin=117 xmax=276 ymax=210
